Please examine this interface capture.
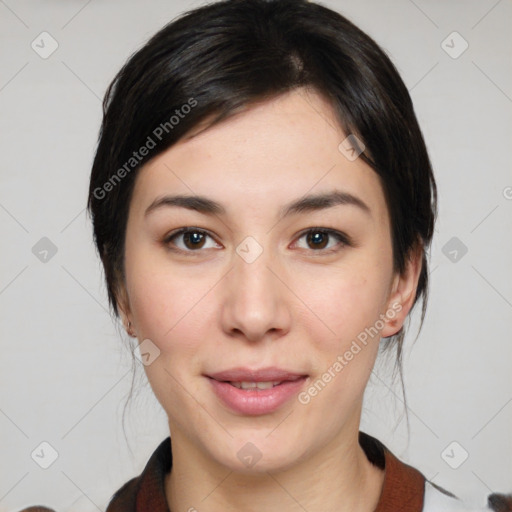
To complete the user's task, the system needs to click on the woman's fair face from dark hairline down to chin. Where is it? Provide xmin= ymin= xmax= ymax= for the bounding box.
xmin=120 ymin=90 xmax=420 ymax=471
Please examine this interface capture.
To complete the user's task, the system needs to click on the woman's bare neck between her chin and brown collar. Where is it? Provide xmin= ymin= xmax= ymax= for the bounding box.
xmin=165 ymin=420 xmax=384 ymax=512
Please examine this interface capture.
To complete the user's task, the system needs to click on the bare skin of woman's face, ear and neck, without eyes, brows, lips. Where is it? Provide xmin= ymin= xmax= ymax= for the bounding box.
xmin=119 ymin=89 xmax=421 ymax=512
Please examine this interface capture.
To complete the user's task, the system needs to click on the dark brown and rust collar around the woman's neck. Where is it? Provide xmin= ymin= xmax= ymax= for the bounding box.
xmin=106 ymin=431 xmax=425 ymax=512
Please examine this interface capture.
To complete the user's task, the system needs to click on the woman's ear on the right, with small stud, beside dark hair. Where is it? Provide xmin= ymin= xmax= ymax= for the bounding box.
xmin=380 ymin=242 xmax=423 ymax=338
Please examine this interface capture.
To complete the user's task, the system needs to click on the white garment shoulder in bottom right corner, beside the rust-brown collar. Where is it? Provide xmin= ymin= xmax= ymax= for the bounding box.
xmin=423 ymin=480 xmax=512 ymax=512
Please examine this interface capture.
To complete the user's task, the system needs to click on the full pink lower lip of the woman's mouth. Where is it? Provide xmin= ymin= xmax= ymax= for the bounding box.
xmin=208 ymin=377 xmax=307 ymax=416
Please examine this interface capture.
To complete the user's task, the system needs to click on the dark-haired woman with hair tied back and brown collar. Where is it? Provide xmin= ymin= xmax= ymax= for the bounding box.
xmin=17 ymin=0 xmax=507 ymax=512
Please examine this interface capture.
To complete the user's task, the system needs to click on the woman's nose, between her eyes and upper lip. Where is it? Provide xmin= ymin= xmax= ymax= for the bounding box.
xmin=221 ymin=243 xmax=293 ymax=342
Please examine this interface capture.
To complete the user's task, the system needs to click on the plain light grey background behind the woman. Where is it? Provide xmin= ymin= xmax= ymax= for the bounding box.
xmin=0 ymin=0 xmax=512 ymax=512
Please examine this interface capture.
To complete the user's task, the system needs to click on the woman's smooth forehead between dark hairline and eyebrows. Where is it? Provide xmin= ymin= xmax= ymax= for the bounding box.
xmin=128 ymin=90 xmax=387 ymax=222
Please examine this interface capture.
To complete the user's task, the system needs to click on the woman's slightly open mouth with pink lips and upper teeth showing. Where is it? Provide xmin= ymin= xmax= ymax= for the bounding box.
xmin=205 ymin=367 xmax=308 ymax=416
